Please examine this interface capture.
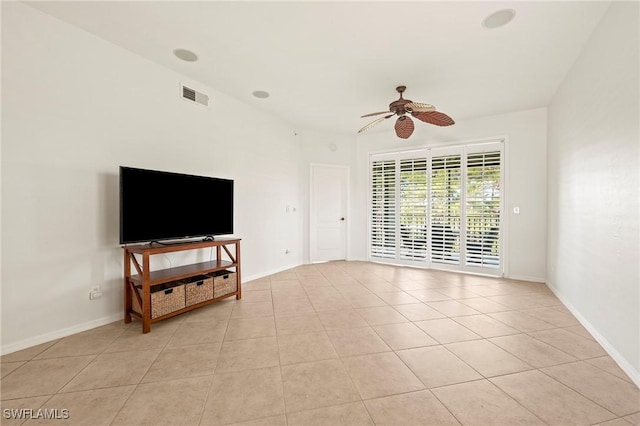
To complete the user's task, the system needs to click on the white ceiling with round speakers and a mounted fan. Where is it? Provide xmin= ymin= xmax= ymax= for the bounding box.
xmin=28 ymin=1 xmax=609 ymax=134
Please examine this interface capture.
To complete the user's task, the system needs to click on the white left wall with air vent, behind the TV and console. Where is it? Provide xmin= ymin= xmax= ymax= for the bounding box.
xmin=2 ymin=2 xmax=304 ymax=353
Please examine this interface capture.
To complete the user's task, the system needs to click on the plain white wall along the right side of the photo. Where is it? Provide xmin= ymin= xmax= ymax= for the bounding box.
xmin=547 ymin=2 xmax=640 ymax=385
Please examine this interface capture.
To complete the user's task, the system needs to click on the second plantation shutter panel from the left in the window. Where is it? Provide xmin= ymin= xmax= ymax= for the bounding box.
xmin=400 ymin=157 xmax=428 ymax=261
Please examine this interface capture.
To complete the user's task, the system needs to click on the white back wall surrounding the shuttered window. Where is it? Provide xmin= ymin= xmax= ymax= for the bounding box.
xmin=353 ymin=108 xmax=547 ymax=282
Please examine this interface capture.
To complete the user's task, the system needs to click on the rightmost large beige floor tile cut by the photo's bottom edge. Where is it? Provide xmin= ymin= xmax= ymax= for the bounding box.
xmin=490 ymin=370 xmax=616 ymax=425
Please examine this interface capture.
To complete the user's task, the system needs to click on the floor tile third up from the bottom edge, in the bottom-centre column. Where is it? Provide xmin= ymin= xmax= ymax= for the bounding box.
xmin=278 ymin=331 xmax=338 ymax=365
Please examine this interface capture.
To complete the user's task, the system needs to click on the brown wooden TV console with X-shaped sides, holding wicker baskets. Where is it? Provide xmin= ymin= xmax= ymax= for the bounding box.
xmin=123 ymin=238 xmax=242 ymax=333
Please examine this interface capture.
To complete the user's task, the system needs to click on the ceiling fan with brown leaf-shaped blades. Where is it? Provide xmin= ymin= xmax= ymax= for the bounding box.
xmin=358 ymin=86 xmax=455 ymax=139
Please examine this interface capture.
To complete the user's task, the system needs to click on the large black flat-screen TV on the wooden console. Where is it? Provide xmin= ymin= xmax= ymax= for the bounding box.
xmin=120 ymin=166 xmax=233 ymax=244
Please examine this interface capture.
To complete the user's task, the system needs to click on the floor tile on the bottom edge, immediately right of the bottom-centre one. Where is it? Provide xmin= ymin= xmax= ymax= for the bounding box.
xmin=364 ymin=390 xmax=460 ymax=426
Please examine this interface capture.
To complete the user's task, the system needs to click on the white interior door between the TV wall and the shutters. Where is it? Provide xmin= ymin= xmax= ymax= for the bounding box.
xmin=309 ymin=164 xmax=349 ymax=262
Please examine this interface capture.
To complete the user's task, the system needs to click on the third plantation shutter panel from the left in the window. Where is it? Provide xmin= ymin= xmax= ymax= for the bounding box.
xmin=431 ymin=154 xmax=462 ymax=264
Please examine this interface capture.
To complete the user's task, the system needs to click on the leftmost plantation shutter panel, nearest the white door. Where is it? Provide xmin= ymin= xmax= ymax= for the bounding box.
xmin=370 ymin=160 xmax=396 ymax=259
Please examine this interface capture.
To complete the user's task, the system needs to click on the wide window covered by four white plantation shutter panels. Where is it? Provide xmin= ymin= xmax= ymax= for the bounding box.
xmin=370 ymin=142 xmax=503 ymax=275
